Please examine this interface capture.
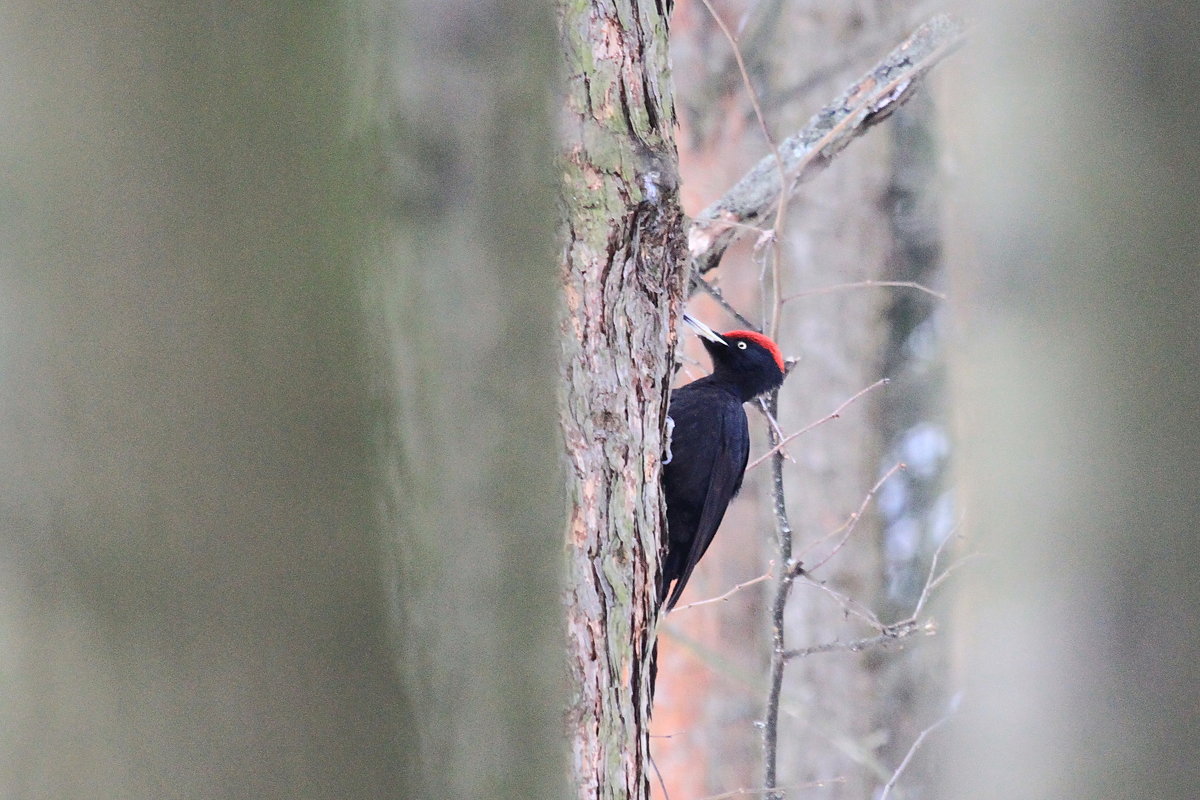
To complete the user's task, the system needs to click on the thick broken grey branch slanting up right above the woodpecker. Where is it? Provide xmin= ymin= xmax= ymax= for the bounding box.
xmin=688 ymin=14 xmax=962 ymax=275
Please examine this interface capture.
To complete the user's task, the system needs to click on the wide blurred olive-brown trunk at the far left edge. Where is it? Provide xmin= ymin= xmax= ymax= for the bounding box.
xmin=0 ymin=2 xmax=407 ymax=799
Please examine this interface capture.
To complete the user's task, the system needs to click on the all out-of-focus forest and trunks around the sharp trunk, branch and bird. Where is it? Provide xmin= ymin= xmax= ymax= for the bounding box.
xmin=0 ymin=0 xmax=1200 ymax=800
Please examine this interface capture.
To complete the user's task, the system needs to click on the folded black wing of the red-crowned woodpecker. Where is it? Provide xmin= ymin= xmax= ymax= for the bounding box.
xmin=666 ymin=392 xmax=750 ymax=610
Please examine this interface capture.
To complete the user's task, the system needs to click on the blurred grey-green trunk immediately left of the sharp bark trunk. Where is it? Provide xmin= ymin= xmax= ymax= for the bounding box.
xmin=361 ymin=0 xmax=565 ymax=798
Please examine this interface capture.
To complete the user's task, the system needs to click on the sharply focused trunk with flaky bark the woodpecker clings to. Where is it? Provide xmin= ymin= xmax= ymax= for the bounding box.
xmin=560 ymin=0 xmax=685 ymax=798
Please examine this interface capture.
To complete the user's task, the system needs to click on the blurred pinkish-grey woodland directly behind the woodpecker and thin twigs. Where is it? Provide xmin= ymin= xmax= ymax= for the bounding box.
xmin=652 ymin=0 xmax=950 ymax=798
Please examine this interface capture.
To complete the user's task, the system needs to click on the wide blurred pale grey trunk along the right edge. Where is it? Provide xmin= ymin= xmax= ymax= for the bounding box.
xmin=943 ymin=1 xmax=1200 ymax=800
